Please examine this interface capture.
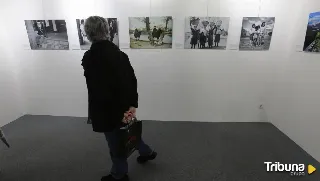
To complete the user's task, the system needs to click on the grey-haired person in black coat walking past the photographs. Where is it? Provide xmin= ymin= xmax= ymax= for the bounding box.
xmin=81 ymin=16 xmax=157 ymax=181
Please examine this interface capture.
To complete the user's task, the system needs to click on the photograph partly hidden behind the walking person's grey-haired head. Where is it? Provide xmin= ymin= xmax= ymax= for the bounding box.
xmin=76 ymin=18 xmax=119 ymax=50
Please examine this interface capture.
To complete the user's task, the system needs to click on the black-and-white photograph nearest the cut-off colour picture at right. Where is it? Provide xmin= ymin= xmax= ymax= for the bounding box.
xmin=239 ymin=17 xmax=275 ymax=51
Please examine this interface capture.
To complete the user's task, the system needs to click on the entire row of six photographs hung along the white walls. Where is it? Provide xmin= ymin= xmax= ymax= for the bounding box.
xmin=25 ymin=12 xmax=320 ymax=52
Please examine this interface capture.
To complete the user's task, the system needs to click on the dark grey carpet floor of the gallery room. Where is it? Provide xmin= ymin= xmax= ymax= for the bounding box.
xmin=0 ymin=115 xmax=320 ymax=181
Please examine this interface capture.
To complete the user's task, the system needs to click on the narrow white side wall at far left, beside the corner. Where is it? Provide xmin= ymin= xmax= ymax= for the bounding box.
xmin=0 ymin=2 xmax=24 ymax=126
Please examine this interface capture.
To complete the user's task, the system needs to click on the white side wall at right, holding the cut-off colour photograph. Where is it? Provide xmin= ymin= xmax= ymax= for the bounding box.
xmin=265 ymin=0 xmax=320 ymax=161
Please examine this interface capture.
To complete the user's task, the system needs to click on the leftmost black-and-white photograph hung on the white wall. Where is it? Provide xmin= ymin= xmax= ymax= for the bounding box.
xmin=25 ymin=20 xmax=69 ymax=50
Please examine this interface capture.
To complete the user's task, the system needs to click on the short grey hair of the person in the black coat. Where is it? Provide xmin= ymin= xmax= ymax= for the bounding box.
xmin=84 ymin=16 xmax=109 ymax=42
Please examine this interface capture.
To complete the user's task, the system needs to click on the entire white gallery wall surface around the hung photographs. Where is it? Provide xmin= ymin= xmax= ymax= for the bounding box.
xmin=0 ymin=0 xmax=320 ymax=160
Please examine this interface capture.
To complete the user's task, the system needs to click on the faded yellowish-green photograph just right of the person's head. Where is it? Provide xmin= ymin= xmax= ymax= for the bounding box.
xmin=129 ymin=16 xmax=173 ymax=49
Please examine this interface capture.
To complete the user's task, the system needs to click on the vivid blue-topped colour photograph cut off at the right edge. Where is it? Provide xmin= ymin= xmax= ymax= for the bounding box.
xmin=303 ymin=12 xmax=320 ymax=53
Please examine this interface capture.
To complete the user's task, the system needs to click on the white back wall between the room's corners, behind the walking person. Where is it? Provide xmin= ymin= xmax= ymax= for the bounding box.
xmin=9 ymin=0 xmax=287 ymax=122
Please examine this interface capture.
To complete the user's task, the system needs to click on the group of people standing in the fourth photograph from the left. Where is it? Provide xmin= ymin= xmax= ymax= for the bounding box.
xmin=190 ymin=20 xmax=224 ymax=49
